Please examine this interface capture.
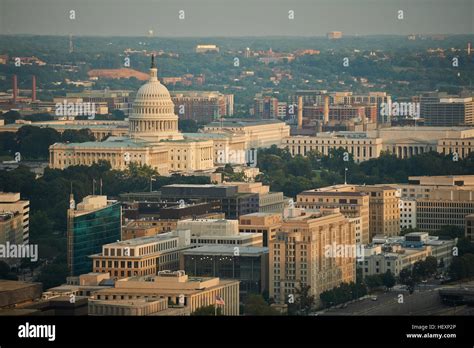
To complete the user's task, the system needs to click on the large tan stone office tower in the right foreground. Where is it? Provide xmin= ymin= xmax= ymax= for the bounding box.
xmin=269 ymin=208 xmax=356 ymax=305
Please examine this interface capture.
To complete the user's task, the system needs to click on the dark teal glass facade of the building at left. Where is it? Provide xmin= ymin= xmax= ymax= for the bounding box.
xmin=70 ymin=203 xmax=121 ymax=276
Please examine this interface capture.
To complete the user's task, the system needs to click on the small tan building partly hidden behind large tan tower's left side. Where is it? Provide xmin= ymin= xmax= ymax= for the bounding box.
xmin=239 ymin=213 xmax=283 ymax=247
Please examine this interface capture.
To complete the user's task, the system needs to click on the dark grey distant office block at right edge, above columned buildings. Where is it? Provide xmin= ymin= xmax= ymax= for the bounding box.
xmin=420 ymin=93 xmax=474 ymax=127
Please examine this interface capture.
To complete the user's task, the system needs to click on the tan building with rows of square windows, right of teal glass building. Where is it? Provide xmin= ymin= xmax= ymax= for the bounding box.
xmin=90 ymin=231 xmax=191 ymax=278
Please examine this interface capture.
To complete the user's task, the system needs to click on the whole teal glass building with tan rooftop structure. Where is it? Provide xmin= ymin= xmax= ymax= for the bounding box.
xmin=67 ymin=196 xmax=122 ymax=276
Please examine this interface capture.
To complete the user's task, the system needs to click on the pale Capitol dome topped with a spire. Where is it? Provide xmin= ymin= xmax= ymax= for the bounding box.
xmin=129 ymin=56 xmax=183 ymax=141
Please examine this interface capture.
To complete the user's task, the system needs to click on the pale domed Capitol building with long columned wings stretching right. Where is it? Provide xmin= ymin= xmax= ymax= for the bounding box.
xmin=49 ymin=57 xmax=289 ymax=175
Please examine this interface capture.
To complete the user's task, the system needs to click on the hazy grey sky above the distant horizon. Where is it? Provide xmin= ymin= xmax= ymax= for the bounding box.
xmin=0 ymin=0 xmax=474 ymax=37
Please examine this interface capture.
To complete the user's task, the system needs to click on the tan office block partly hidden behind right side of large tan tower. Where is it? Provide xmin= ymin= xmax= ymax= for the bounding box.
xmin=296 ymin=185 xmax=370 ymax=244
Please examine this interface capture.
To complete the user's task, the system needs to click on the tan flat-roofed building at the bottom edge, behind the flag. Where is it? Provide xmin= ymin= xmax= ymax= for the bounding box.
xmin=93 ymin=271 xmax=239 ymax=315
